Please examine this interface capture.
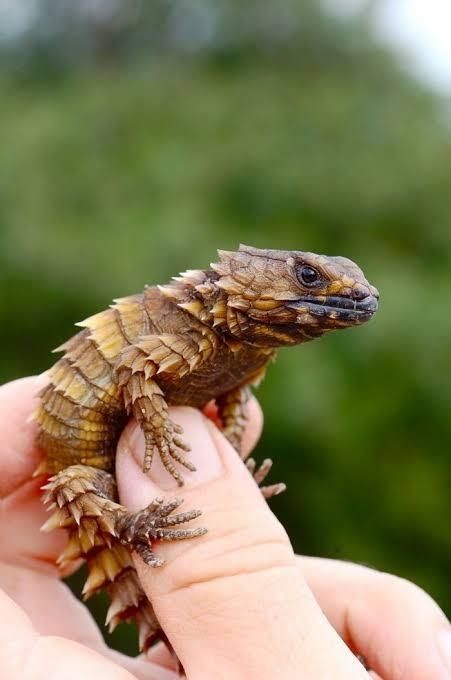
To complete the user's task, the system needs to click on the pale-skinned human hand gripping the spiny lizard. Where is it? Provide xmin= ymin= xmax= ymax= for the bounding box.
xmin=0 ymin=377 xmax=451 ymax=680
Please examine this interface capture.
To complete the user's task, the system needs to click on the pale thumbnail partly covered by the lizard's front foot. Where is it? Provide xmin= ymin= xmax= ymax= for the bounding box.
xmin=128 ymin=406 xmax=223 ymax=491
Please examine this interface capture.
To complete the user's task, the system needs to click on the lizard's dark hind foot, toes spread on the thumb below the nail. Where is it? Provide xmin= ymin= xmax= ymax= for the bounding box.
xmin=117 ymin=498 xmax=207 ymax=567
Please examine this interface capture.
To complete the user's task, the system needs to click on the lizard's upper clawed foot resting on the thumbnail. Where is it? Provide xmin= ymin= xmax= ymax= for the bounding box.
xmin=143 ymin=419 xmax=196 ymax=486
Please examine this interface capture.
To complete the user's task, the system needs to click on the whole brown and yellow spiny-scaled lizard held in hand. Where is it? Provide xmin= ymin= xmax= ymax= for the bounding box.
xmin=36 ymin=246 xmax=378 ymax=649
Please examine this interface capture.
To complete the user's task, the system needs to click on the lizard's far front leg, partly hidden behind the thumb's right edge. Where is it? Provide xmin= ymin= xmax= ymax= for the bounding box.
xmin=216 ymin=386 xmax=286 ymax=499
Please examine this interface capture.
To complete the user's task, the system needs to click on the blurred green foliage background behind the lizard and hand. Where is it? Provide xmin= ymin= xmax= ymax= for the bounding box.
xmin=0 ymin=0 xmax=451 ymax=651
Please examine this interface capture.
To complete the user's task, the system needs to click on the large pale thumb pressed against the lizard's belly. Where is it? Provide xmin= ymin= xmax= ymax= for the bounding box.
xmin=117 ymin=407 xmax=368 ymax=680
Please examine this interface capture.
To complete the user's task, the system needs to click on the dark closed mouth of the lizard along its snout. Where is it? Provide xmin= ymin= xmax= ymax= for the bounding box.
xmin=289 ymin=295 xmax=378 ymax=323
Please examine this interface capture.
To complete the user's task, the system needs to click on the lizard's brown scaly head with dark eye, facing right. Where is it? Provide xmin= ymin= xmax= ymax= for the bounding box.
xmin=211 ymin=245 xmax=379 ymax=346
